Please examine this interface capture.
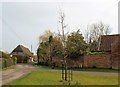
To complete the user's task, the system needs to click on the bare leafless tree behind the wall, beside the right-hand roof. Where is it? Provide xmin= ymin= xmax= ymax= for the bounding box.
xmin=86 ymin=22 xmax=111 ymax=51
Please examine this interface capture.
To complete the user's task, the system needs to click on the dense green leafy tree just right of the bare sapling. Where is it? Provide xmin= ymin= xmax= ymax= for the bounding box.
xmin=66 ymin=30 xmax=87 ymax=58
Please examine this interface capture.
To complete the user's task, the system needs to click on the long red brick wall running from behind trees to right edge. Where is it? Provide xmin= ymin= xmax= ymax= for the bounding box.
xmin=50 ymin=51 xmax=120 ymax=69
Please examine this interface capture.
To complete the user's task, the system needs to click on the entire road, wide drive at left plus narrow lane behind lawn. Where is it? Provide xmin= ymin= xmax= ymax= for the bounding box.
xmin=0 ymin=64 xmax=118 ymax=85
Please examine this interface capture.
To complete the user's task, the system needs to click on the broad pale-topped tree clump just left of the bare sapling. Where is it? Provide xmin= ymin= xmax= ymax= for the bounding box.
xmin=37 ymin=31 xmax=63 ymax=65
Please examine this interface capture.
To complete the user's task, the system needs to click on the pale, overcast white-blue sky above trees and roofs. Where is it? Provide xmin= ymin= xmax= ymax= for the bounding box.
xmin=0 ymin=0 xmax=119 ymax=53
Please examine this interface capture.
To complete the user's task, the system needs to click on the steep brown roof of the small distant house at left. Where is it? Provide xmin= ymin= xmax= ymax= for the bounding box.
xmin=11 ymin=45 xmax=32 ymax=56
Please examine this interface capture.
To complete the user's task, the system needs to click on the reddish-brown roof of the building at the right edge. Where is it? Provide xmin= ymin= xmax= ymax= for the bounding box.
xmin=100 ymin=34 xmax=120 ymax=51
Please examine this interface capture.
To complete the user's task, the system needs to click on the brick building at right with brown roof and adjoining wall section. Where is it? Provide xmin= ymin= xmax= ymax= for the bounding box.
xmin=84 ymin=34 xmax=120 ymax=69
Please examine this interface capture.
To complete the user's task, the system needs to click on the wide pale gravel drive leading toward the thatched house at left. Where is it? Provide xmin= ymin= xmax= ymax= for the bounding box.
xmin=0 ymin=64 xmax=35 ymax=85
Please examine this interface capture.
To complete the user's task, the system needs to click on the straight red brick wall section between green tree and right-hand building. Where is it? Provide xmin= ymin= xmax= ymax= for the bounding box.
xmin=84 ymin=54 xmax=111 ymax=68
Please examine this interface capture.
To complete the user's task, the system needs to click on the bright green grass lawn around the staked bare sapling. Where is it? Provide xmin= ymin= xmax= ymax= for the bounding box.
xmin=6 ymin=70 xmax=118 ymax=85
